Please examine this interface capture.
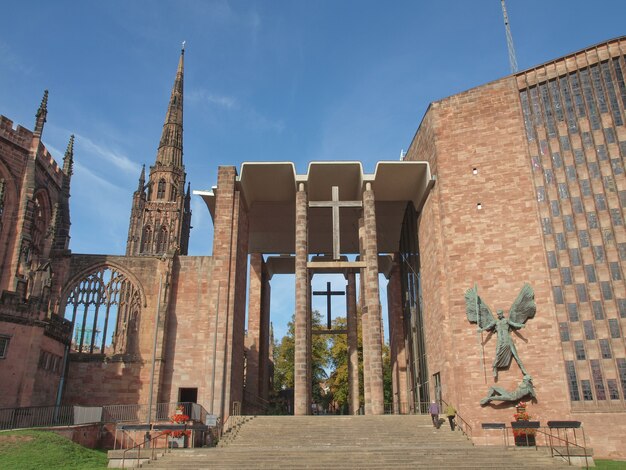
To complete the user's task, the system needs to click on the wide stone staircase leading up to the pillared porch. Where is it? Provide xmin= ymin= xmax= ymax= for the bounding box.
xmin=144 ymin=415 xmax=567 ymax=470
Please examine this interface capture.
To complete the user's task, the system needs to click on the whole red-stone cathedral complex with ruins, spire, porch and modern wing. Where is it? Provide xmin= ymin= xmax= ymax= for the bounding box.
xmin=0 ymin=38 xmax=626 ymax=457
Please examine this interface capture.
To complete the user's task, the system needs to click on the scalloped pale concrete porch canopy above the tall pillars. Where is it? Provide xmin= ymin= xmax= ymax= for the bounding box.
xmin=194 ymin=161 xmax=434 ymax=254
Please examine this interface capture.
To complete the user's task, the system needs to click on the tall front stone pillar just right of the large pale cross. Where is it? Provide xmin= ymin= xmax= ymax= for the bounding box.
xmin=363 ymin=182 xmax=385 ymax=415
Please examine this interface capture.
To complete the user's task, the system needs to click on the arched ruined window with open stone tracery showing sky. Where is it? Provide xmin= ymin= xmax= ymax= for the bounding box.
xmin=65 ymin=266 xmax=141 ymax=354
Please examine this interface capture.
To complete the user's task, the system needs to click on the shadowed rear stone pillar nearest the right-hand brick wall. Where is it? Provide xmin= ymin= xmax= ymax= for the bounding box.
xmin=387 ymin=254 xmax=409 ymax=414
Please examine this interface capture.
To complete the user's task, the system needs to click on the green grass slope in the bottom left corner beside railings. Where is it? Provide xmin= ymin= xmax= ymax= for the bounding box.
xmin=0 ymin=431 xmax=108 ymax=470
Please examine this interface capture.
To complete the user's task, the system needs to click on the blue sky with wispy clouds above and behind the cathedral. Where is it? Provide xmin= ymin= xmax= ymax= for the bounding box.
xmin=0 ymin=0 xmax=626 ymax=336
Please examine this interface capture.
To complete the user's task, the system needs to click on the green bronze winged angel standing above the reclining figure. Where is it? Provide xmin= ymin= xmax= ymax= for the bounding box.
xmin=465 ymin=284 xmax=537 ymax=379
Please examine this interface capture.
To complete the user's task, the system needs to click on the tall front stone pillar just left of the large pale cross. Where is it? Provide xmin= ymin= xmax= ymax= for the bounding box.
xmin=294 ymin=183 xmax=311 ymax=415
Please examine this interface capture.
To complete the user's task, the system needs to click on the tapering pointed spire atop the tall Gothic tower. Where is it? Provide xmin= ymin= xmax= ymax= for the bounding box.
xmin=156 ymin=44 xmax=185 ymax=167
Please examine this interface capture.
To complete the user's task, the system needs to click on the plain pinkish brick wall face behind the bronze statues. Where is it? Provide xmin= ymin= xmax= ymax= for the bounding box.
xmin=409 ymin=79 xmax=570 ymax=442
